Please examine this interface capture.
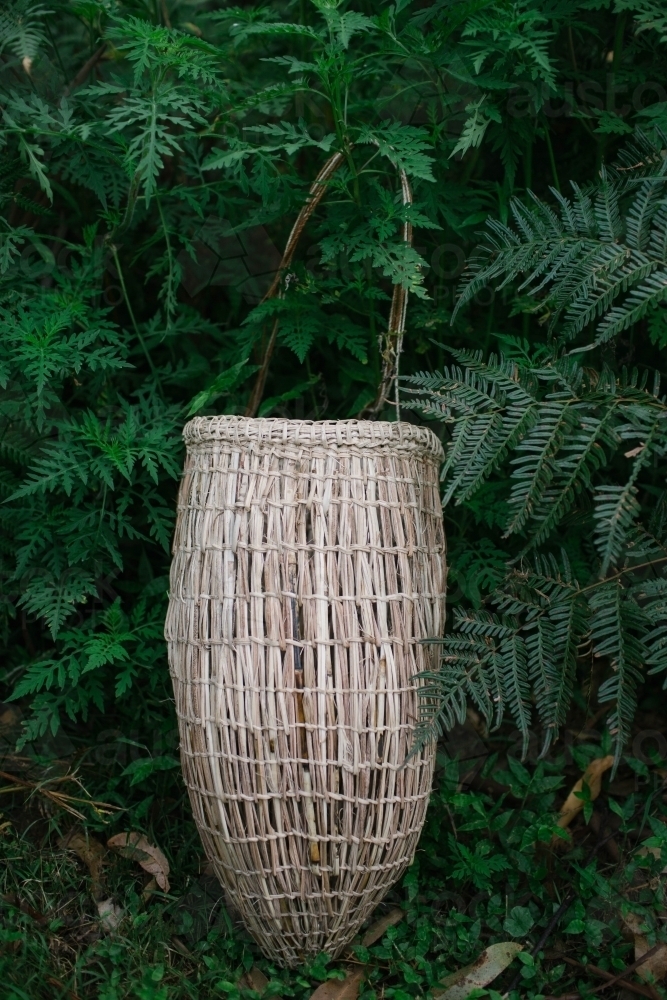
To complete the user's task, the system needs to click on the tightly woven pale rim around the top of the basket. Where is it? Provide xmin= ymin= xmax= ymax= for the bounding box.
xmin=183 ymin=414 xmax=444 ymax=461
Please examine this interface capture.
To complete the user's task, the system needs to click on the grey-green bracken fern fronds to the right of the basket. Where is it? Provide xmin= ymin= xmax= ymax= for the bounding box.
xmin=404 ymin=137 xmax=667 ymax=761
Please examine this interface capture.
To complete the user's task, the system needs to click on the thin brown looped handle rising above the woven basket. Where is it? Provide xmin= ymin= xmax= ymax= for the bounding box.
xmin=245 ymin=144 xmax=412 ymax=420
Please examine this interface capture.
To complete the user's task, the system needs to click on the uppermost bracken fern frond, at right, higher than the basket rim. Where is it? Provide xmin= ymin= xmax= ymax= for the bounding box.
xmin=454 ymin=138 xmax=667 ymax=343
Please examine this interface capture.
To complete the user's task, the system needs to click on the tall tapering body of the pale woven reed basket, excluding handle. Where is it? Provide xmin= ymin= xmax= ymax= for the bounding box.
xmin=166 ymin=416 xmax=445 ymax=966
